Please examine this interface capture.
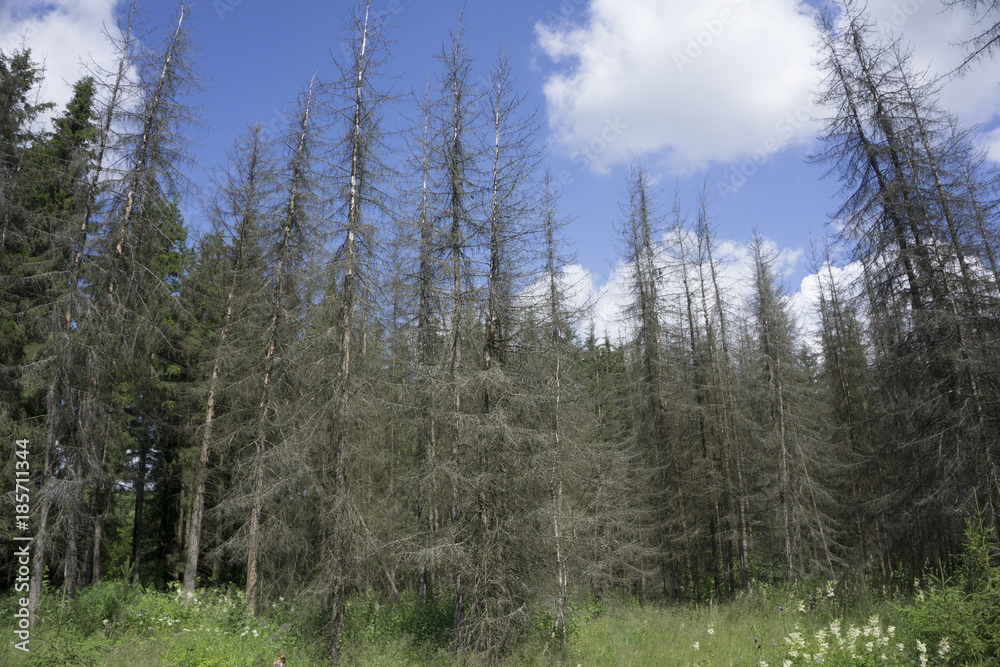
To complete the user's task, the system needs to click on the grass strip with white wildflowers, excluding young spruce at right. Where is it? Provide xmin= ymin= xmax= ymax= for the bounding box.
xmin=0 ymin=582 xmax=988 ymax=667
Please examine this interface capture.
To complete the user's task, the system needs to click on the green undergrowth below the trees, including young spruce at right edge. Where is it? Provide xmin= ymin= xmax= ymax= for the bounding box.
xmin=0 ymin=513 xmax=1000 ymax=667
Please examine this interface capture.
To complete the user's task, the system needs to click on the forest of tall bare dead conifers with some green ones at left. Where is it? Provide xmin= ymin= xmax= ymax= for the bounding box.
xmin=0 ymin=1 xmax=1000 ymax=658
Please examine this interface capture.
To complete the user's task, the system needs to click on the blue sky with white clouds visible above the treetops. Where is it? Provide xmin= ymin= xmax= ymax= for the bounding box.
xmin=7 ymin=0 xmax=1000 ymax=340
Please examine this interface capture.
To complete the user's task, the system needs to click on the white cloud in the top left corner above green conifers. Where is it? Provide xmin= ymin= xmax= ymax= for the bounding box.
xmin=0 ymin=0 xmax=120 ymax=115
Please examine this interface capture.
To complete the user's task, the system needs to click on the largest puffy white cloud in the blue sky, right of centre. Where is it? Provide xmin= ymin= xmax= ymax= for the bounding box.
xmin=536 ymin=0 xmax=815 ymax=173
